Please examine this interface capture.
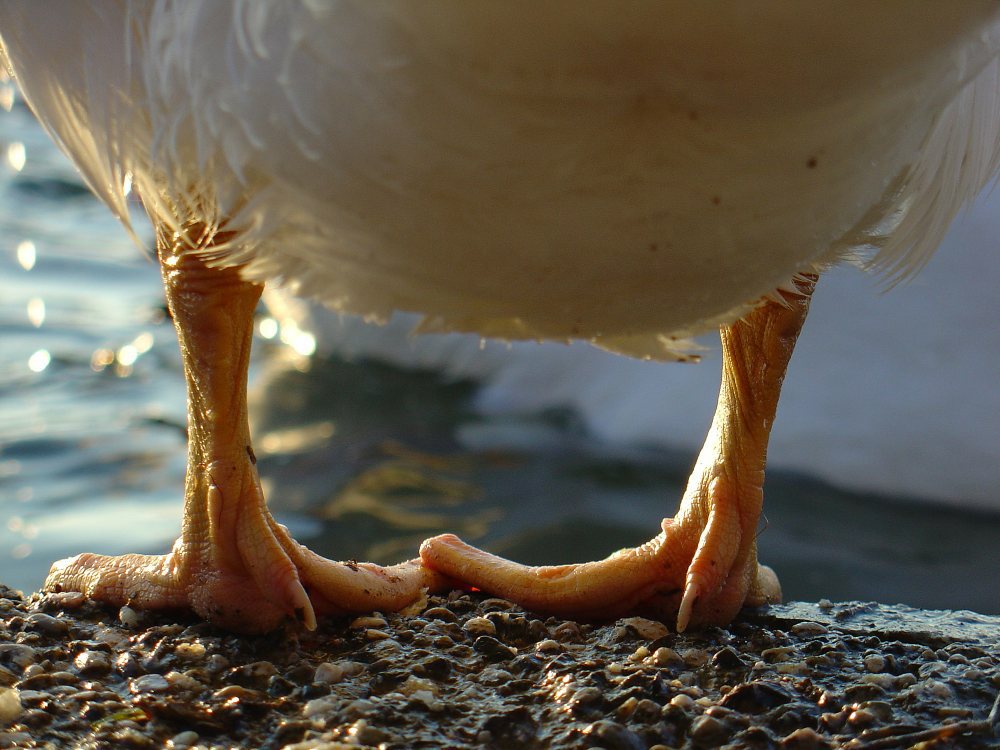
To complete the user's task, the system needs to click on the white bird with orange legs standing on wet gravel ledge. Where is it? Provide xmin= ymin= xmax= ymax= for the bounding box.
xmin=0 ymin=0 xmax=1000 ymax=631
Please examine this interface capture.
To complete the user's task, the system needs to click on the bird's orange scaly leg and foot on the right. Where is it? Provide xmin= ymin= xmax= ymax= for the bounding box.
xmin=420 ymin=275 xmax=816 ymax=632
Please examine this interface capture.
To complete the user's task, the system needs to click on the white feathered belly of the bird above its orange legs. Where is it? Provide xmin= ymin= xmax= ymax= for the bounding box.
xmin=0 ymin=0 xmax=1000 ymax=357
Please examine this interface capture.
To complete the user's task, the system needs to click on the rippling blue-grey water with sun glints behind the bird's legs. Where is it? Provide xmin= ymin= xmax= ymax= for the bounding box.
xmin=0 ymin=91 xmax=1000 ymax=613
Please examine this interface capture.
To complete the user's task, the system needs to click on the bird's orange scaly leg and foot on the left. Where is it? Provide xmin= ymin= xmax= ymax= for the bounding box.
xmin=45 ymin=227 xmax=447 ymax=633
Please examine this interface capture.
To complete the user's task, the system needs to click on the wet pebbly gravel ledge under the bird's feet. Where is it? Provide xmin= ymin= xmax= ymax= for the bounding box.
xmin=0 ymin=585 xmax=1000 ymax=750
